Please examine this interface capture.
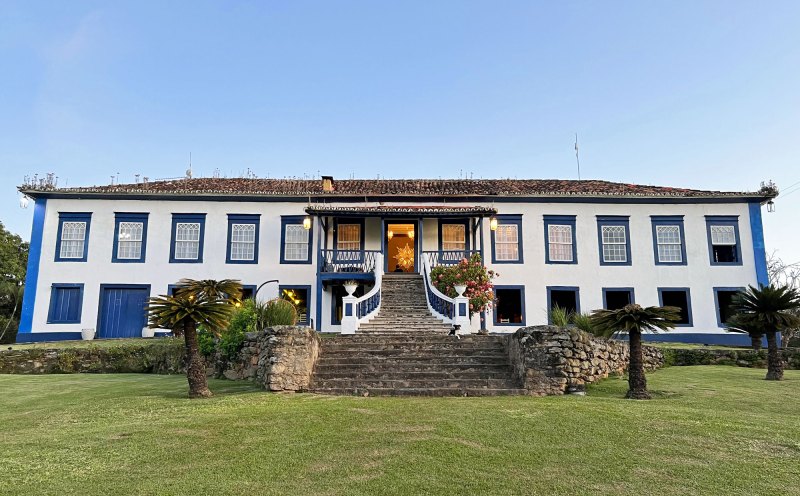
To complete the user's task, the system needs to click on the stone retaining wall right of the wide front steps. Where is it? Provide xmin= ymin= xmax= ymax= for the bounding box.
xmin=508 ymin=326 xmax=664 ymax=396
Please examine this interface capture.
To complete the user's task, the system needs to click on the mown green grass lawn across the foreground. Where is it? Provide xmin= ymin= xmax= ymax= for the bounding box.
xmin=0 ymin=366 xmax=800 ymax=495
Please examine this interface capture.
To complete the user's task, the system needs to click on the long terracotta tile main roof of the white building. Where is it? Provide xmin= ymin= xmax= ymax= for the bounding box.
xmin=19 ymin=178 xmax=765 ymax=198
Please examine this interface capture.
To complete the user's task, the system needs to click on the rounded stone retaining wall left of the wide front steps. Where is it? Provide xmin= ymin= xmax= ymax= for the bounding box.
xmin=222 ymin=326 xmax=320 ymax=391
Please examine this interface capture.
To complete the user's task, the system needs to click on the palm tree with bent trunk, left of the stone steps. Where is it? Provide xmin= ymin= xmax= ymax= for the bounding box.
xmin=147 ymin=279 xmax=242 ymax=398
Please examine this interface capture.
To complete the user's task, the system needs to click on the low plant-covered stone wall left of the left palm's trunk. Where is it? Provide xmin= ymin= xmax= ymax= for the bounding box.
xmin=0 ymin=339 xmax=186 ymax=374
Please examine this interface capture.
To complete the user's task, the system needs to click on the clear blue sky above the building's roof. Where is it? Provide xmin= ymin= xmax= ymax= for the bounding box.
xmin=0 ymin=0 xmax=800 ymax=261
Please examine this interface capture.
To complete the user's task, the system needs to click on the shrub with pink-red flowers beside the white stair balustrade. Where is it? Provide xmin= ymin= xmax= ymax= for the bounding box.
xmin=431 ymin=253 xmax=500 ymax=316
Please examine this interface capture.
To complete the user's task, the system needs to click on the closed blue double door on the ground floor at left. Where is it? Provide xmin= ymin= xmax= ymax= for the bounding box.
xmin=97 ymin=285 xmax=150 ymax=338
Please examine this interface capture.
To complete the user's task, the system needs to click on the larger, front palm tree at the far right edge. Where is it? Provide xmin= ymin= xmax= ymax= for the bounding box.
xmin=731 ymin=284 xmax=800 ymax=381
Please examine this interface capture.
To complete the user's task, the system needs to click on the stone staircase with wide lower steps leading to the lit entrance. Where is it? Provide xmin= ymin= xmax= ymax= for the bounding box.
xmin=310 ymin=274 xmax=526 ymax=396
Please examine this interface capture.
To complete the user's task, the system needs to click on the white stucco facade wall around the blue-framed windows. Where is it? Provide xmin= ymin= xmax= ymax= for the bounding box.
xmin=25 ymin=199 xmax=756 ymax=333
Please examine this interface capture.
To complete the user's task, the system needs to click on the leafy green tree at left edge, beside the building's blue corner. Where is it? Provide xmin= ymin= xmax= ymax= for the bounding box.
xmin=0 ymin=222 xmax=29 ymax=343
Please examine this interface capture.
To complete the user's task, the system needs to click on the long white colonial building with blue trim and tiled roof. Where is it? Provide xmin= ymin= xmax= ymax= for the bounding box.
xmin=17 ymin=177 xmax=770 ymax=343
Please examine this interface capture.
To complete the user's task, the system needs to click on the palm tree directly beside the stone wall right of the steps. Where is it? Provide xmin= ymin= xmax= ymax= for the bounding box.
xmin=591 ymin=303 xmax=680 ymax=400
